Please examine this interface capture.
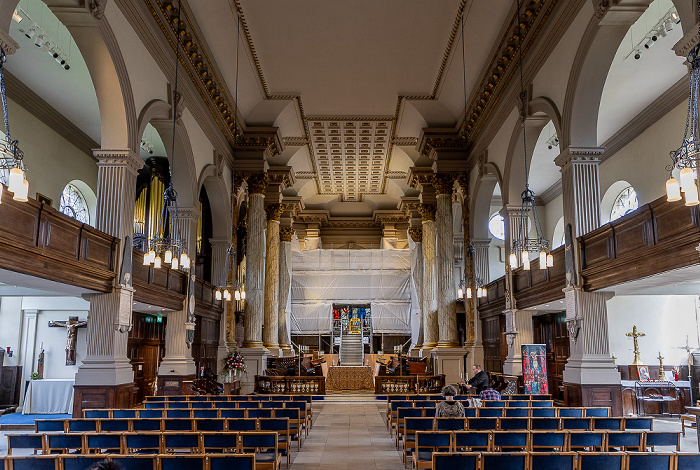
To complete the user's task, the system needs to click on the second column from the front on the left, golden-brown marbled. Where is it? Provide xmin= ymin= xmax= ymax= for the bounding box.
xmin=263 ymin=204 xmax=282 ymax=356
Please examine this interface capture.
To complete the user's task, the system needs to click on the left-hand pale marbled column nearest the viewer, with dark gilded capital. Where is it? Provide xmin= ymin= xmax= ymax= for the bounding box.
xmin=243 ymin=173 xmax=267 ymax=348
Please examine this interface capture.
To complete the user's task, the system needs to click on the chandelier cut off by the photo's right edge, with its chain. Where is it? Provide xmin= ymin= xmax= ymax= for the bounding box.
xmin=666 ymin=39 xmax=700 ymax=206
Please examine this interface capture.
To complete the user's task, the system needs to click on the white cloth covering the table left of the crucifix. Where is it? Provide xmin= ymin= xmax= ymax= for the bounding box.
xmin=22 ymin=379 xmax=74 ymax=415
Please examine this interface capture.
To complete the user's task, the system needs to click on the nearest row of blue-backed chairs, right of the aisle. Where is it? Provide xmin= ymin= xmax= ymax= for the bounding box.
xmin=421 ymin=452 xmax=700 ymax=470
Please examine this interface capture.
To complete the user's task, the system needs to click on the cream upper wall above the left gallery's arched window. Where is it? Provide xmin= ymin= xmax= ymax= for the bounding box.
xmin=8 ymin=96 xmax=97 ymax=210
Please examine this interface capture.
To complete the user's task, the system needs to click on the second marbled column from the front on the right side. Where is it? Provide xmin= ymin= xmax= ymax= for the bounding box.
xmin=420 ymin=204 xmax=438 ymax=351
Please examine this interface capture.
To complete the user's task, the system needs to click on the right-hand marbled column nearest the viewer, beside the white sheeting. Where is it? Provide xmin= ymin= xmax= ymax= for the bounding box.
xmin=434 ymin=175 xmax=459 ymax=348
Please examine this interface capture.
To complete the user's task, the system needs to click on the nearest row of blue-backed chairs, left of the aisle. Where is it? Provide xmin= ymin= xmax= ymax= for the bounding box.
xmin=3 ymin=454 xmax=260 ymax=470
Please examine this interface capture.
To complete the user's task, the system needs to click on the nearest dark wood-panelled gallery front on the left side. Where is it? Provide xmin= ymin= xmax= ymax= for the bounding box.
xmin=0 ymin=188 xmax=119 ymax=292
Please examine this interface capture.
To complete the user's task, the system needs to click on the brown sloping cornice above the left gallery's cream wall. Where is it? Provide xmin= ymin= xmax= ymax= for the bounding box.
xmin=5 ymin=70 xmax=100 ymax=161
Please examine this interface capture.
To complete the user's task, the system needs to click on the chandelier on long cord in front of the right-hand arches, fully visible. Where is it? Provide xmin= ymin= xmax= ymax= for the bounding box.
xmin=510 ymin=1 xmax=554 ymax=271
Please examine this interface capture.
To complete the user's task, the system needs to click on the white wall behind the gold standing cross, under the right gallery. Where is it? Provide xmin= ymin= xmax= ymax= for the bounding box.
xmin=607 ymin=295 xmax=700 ymax=366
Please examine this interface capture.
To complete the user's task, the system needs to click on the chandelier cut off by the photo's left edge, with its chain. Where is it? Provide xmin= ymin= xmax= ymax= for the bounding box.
xmin=0 ymin=47 xmax=29 ymax=202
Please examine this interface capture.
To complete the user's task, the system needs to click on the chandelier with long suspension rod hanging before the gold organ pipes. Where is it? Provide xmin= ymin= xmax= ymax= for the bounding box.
xmin=143 ymin=0 xmax=191 ymax=270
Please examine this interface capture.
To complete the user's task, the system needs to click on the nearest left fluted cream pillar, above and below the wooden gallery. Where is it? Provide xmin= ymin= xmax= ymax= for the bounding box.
xmin=74 ymin=149 xmax=143 ymax=392
